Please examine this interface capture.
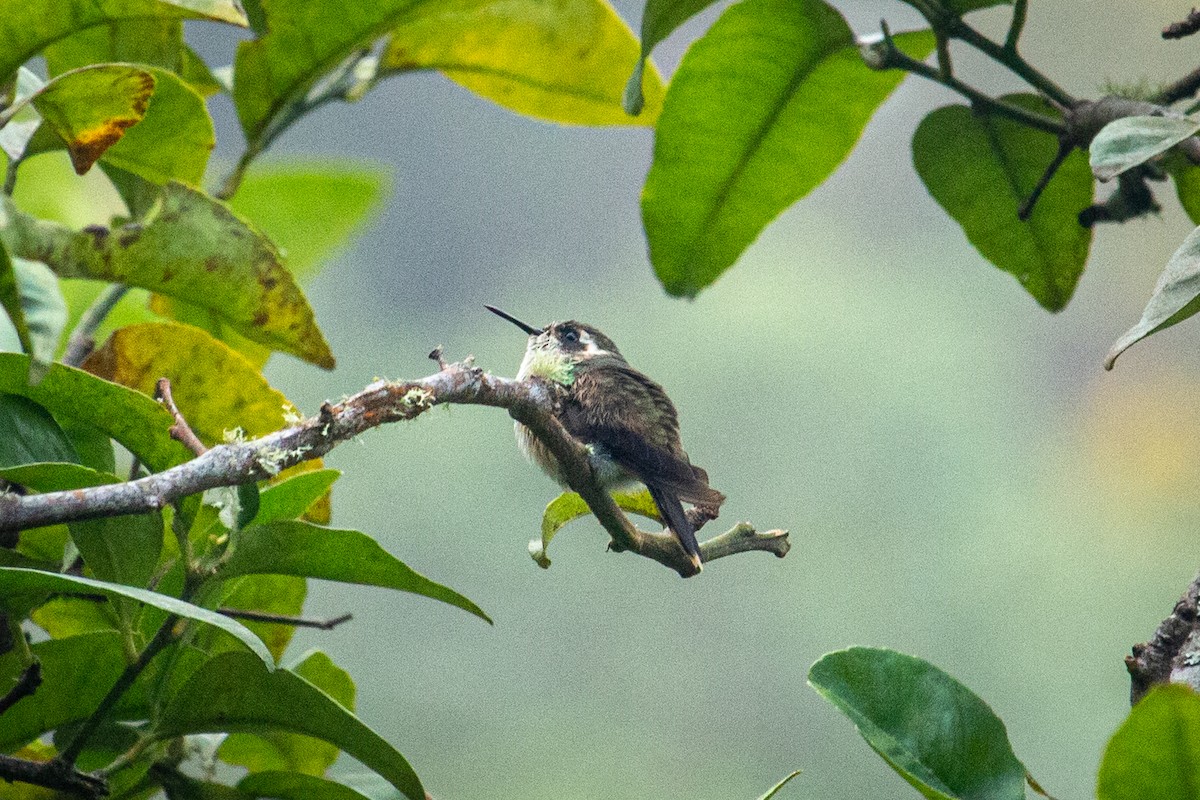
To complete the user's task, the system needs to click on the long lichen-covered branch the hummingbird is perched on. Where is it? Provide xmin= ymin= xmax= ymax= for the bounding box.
xmin=0 ymin=363 xmax=787 ymax=577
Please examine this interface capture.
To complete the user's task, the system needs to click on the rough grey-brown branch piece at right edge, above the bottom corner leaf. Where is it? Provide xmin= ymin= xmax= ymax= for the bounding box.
xmin=1126 ymin=576 xmax=1200 ymax=704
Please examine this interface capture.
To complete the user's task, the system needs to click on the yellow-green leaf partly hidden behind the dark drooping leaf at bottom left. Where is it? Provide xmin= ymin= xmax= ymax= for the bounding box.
xmin=217 ymin=650 xmax=354 ymax=777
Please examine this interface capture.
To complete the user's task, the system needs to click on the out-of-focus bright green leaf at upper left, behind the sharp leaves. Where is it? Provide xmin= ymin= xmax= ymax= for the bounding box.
xmin=229 ymin=161 xmax=389 ymax=284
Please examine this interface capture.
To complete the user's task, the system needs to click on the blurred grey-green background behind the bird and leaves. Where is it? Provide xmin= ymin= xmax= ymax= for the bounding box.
xmin=49 ymin=0 xmax=1200 ymax=800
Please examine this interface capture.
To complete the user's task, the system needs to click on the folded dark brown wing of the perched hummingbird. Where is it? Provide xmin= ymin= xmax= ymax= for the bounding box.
xmin=562 ymin=363 xmax=725 ymax=506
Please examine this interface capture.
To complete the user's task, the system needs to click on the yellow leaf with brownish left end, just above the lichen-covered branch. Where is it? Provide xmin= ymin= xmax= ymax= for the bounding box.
xmin=83 ymin=323 xmax=330 ymax=523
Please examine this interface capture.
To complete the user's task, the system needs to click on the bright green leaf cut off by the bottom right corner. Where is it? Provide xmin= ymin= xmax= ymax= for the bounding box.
xmin=1096 ymin=684 xmax=1200 ymax=800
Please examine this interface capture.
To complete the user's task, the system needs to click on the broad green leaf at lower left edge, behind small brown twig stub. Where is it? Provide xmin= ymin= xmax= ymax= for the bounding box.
xmin=0 ymin=632 xmax=125 ymax=753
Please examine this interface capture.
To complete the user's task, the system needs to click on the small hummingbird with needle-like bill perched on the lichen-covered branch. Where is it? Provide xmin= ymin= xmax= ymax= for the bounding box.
xmin=485 ymin=306 xmax=725 ymax=571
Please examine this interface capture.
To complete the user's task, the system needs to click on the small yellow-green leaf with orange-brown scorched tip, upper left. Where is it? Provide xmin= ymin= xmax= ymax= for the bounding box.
xmin=0 ymin=64 xmax=155 ymax=175
